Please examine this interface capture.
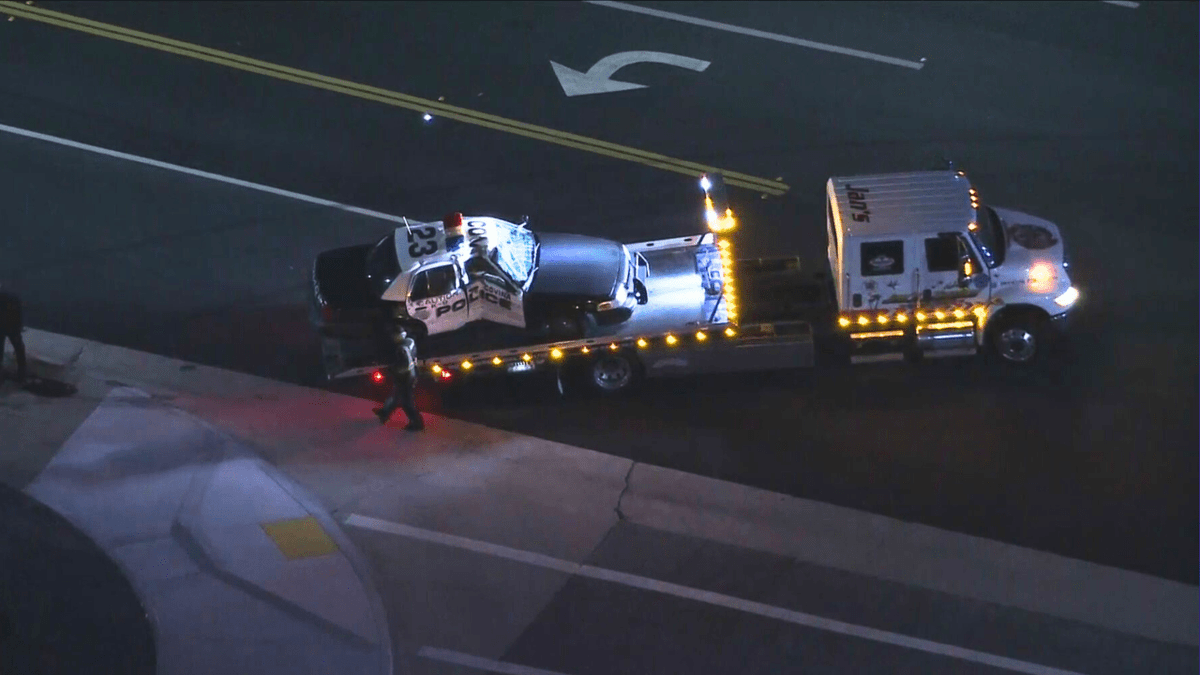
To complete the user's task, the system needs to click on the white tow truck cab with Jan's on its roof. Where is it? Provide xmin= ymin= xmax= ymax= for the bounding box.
xmin=826 ymin=171 xmax=1079 ymax=364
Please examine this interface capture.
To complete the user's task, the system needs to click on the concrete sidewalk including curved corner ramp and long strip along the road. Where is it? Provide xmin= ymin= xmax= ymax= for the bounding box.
xmin=0 ymin=330 xmax=1200 ymax=674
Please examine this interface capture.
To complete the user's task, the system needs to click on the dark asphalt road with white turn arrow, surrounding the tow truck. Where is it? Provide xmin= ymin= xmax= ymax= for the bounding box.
xmin=0 ymin=2 xmax=1200 ymax=584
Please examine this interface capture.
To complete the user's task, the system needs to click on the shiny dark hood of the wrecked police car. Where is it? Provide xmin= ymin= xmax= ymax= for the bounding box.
xmin=529 ymin=233 xmax=626 ymax=299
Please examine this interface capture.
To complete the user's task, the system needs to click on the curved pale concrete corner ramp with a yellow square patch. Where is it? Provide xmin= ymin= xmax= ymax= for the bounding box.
xmin=0 ymin=331 xmax=392 ymax=675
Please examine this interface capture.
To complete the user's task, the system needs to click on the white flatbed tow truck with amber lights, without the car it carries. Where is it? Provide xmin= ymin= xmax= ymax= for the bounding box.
xmin=323 ymin=169 xmax=1080 ymax=394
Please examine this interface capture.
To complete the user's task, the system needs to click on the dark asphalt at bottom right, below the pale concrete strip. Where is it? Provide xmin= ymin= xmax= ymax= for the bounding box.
xmin=348 ymin=509 xmax=1196 ymax=675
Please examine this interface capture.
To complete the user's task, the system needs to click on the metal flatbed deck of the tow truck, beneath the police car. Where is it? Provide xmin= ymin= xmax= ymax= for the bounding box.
xmin=322 ymin=229 xmax=826 ymax=378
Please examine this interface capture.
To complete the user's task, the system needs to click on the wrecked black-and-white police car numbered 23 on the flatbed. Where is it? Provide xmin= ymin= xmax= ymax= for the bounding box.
xmin=312 ymin=214 xmax=649 ymax=339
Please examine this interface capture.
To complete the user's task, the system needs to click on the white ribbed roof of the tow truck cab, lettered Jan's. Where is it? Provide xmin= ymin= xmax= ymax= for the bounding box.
xmin=827 ymin=171 xmax=976 ymax=238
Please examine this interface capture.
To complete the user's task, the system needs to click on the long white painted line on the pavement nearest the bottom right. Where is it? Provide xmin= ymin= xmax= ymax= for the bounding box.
xmin=344 ymin=513 xmax=1081 ymax=675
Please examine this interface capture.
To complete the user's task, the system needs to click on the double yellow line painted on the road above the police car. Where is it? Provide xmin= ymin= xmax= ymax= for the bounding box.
xmin=0 ymin=0 xmax=788 ymax=196
